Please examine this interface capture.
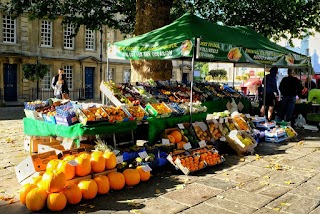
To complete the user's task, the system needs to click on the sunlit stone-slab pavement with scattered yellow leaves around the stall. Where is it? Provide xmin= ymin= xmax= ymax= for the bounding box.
xmin=0 ymin=108 xmax=320 ymax=214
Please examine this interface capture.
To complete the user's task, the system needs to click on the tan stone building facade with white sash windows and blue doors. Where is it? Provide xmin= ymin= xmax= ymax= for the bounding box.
xmin=0 ymin=12 xmax=188 ymax=102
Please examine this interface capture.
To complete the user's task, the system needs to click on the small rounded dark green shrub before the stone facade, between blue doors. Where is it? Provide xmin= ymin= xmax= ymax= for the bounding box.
xmin=22 ymin=63 xmax=49 ymax=81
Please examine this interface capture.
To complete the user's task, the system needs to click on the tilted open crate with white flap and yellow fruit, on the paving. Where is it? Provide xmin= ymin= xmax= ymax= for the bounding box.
xmin=227 ymin=130 xmax=258 ymax=155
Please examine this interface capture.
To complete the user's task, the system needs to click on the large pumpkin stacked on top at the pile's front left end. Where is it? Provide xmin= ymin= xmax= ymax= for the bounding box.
xmin=40 ymin=171 xmax=67 ymax=192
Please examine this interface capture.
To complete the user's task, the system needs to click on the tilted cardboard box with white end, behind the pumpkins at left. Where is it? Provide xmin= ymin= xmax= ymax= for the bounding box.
xmin=15 ymin=151 xmax=58 ymax=183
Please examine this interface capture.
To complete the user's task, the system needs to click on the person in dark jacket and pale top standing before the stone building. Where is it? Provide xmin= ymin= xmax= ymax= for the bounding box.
xmin=51 ymin=68 xmax=69 ymax=99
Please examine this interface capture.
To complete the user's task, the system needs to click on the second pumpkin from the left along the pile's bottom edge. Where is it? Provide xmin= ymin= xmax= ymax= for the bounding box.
xmin=26 ymin=188 xmax=47 ymax=212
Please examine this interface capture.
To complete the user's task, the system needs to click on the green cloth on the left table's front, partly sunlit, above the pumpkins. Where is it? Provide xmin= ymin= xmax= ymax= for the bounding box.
xmin=23 ymin=118 xmax=137 ymax=138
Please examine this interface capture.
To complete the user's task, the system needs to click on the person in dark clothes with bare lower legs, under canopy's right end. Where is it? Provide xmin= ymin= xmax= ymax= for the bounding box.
xmin=260 ymin=66 xmax=279 ymax=121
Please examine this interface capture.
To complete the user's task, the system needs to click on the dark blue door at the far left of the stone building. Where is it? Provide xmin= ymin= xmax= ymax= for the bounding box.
xmin=3 ymin=64 xmax=18 ymax=101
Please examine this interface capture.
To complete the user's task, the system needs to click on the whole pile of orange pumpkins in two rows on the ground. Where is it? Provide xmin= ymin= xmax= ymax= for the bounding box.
xmin=20 ymin=151 xmax=150 ymax=212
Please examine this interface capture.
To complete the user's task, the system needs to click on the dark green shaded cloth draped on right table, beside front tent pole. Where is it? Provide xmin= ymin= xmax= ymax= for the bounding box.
xmin=148 ymin=112 xmax=207 ymax=144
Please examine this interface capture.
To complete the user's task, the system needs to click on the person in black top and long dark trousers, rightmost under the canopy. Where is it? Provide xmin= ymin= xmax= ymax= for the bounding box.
xmin=279 ymin=68 xmax=303 ymax=122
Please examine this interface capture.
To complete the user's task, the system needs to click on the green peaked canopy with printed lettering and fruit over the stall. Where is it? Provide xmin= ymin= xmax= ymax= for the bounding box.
xmin=108 ymin=13 xmax=309 ymax=67
